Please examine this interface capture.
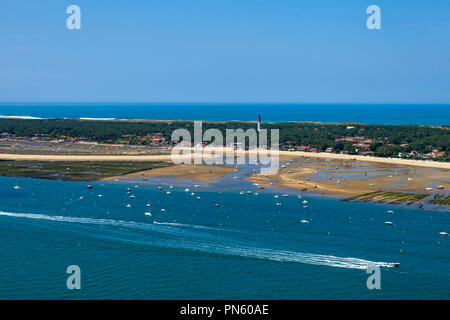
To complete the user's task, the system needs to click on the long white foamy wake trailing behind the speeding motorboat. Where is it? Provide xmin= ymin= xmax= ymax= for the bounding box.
xmin=0 ymin=211 xmax=394 ymax=270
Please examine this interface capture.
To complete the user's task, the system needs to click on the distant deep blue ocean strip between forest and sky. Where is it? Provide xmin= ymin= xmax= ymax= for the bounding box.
xmin=0 ymin=103 xmax=450 ymax=125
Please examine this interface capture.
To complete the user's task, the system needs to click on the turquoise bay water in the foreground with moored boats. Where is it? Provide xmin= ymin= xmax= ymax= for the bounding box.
xmin=0 ymin=176 xmax=450 ymax=299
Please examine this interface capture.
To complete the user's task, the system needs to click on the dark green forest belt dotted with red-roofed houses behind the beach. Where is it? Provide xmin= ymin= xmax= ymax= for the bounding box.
xmin=0 ymin=119 xmax=450 ymax=157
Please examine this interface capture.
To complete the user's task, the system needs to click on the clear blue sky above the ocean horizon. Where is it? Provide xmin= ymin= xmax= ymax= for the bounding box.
xmin=0 ymin=0 xmax=450 ymax=103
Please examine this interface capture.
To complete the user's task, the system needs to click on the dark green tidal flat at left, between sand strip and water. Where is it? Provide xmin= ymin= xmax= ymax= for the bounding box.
xmin=0 ymin=161 xmax=170 ymax=181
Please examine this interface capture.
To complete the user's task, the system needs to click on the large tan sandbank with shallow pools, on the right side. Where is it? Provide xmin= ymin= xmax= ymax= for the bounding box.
xmin=247 ymin=156 xmax=450 ymax=201
